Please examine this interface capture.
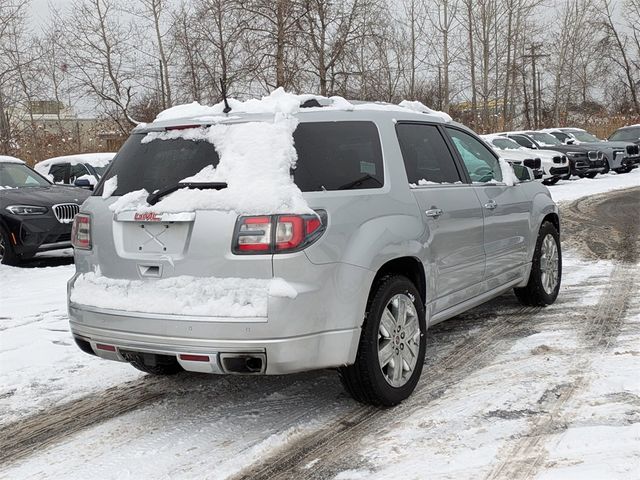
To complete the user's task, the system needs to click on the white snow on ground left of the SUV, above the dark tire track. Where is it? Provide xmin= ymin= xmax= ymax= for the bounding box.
xmin=0 ymin=265 xmax=142 ymax=429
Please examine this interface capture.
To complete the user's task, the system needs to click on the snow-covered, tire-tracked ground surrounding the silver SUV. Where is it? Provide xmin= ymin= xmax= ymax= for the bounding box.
xmin=0 ymin=169 xmax=640 ymax=480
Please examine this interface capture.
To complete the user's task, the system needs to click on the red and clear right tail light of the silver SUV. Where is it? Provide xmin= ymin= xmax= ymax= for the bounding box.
xmin=232 ymin=210 xmax=327 ymax=255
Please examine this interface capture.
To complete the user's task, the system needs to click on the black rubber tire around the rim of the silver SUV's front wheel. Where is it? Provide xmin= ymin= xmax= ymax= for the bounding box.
xmin=513 ymin=222 xmax=562 ymax=307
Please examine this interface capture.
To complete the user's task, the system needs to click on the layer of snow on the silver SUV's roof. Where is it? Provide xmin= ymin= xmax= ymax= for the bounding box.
xmin=147 ymin=88 xmax=452 ymax=128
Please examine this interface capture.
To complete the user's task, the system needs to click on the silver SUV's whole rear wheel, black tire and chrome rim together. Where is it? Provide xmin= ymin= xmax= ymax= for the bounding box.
xmin=339 ymin=275 xmax=426 ymax=406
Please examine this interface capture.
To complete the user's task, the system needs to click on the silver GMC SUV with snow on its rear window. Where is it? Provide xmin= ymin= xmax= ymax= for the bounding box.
xmin=68 ymin=101 xmax=561 ymax=405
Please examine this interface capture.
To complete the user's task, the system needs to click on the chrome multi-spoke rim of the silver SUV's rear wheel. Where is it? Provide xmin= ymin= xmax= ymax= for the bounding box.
xmin=378 ymin=294 xmax=420 ymax=387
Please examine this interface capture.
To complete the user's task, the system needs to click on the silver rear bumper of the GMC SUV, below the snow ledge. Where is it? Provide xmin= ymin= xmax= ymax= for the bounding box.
xmin=68 ymin=253 xmax=375 ymax=375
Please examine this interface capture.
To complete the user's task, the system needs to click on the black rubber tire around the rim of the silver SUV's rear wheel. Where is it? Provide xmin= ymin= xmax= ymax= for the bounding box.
xmin=338 ymin=275 xmax=426 ymax=407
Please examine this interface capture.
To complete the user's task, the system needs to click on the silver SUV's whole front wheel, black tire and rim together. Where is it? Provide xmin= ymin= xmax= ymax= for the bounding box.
xmin=514 ymin=222 xmax=562 ymax=307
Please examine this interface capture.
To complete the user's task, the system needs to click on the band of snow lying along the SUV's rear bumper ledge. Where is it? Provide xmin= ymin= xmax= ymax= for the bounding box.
xmin=71 ymin=272 xmax=298 ymax=318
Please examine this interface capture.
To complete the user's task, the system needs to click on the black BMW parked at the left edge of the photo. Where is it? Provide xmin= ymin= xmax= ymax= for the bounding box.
xmin=0 ymin=156 xmax=90 ymax=265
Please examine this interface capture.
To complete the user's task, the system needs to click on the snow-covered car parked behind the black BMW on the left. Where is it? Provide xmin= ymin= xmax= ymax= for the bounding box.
xmin=34 ymin=153 xmax=116 ymax=189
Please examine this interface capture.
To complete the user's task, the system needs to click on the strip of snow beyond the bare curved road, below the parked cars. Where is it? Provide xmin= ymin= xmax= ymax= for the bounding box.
xmin=549 ymin=168 xmax=640 ymax=202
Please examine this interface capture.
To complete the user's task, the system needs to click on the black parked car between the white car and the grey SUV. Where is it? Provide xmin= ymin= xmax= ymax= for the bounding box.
xmin=499 ymin=130 xmax=606 ymax=178
